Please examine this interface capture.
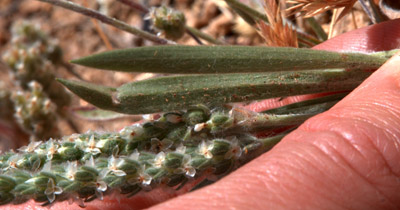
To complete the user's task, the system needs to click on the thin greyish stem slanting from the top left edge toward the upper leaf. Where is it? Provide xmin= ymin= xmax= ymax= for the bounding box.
xmin=38 ymin=0 xmax=176 ymax=45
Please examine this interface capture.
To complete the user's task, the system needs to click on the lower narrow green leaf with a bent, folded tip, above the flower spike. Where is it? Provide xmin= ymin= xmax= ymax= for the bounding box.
xmin=59 ymin=69 xmax=370 ymax=114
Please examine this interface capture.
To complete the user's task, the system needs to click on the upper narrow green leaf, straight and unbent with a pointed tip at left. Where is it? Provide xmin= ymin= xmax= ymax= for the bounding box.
xmin=72 ymin=46 xmax=394 ymax=74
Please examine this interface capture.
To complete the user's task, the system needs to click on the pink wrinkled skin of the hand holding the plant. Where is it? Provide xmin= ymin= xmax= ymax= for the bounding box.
xmin=4 ymin=20 xmax=400 ymax=210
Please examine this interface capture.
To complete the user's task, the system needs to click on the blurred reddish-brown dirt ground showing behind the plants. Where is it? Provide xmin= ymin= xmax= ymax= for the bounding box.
xmin=0 ymin=0 xmax=369 ymax=148
